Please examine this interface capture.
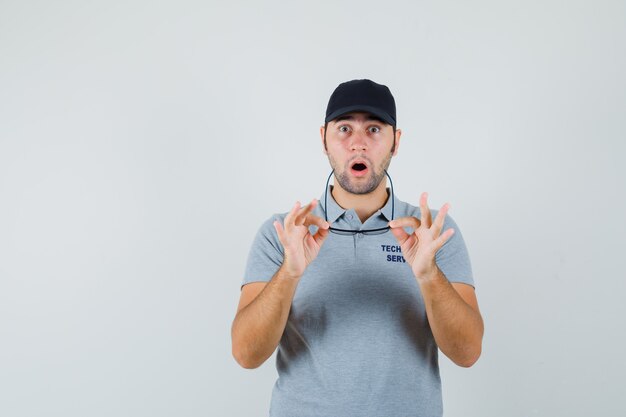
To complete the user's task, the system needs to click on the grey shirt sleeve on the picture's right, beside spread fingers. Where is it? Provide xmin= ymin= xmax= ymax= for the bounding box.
xmin=432 ymin=214 xmax=475 ymax=287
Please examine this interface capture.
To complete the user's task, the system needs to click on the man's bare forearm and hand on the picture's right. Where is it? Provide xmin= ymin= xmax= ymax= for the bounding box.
xmin=390 ymin=193 xmax=484 ymax=367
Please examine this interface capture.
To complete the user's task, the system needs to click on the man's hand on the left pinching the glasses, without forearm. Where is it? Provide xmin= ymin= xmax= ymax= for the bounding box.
xmin=274 ymin=200 xmax=330 ymax=279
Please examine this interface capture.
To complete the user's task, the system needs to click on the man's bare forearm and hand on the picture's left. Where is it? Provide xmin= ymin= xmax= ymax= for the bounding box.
xmin=231 ymin=200 xmax=329 ymax=368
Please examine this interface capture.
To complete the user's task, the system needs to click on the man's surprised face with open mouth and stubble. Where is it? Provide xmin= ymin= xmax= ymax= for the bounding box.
xmin=320 ymin=112 xmax=402 ymax=194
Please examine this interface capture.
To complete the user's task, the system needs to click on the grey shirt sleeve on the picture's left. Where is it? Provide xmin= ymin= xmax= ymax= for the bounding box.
xmin=241 ymin=213 xmax=286 ymax=287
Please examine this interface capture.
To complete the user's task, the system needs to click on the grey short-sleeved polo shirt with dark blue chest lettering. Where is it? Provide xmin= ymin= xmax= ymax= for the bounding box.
xmin=243 ymin=186 xmax=474 ymax=417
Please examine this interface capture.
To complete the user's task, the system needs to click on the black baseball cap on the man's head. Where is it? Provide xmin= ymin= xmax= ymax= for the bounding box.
xmin=325 ymin=80 xmax=396 ymax=127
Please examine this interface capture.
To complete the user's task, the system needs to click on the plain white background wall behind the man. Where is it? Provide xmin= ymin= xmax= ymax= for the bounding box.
xmin=0 ymin=0 xmax=626 ymax=417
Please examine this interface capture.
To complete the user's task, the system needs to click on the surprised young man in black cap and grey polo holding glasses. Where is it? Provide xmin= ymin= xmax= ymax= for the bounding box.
xmin=232 ymin=80 xmax=483 ymax=417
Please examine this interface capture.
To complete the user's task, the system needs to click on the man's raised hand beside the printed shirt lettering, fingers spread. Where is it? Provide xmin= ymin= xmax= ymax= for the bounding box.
xmin=389 ymin=193 xmax=454 ymax=282
